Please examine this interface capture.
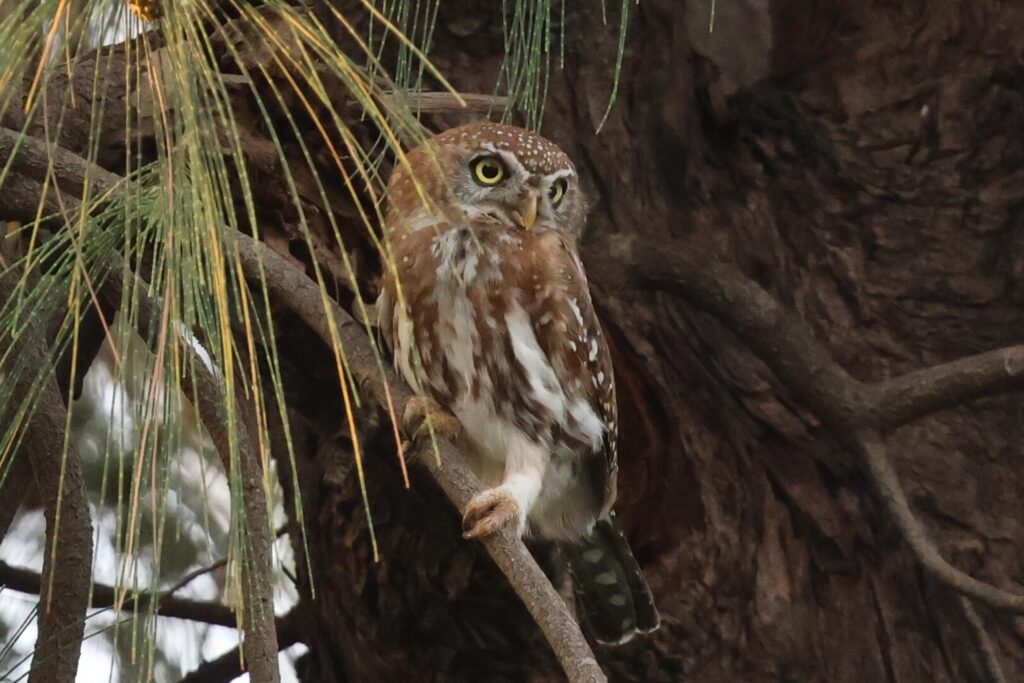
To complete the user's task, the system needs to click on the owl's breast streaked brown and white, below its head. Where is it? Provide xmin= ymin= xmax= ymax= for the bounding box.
xmin=394 ymin=229 xmax=607 ymax=460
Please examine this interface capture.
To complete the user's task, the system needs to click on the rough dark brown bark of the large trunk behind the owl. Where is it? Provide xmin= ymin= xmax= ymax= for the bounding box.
xmin=7 ymin=0 xmax=1024 ymax=683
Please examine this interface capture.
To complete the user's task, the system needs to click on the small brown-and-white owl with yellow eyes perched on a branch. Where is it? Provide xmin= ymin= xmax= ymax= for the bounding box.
xmin=377 ymin=123 xmax=658 ymax=643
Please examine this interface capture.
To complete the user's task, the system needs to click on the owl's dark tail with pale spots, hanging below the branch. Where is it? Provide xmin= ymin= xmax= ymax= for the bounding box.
xmin=561 ymin=517 xmax=662 ymax=645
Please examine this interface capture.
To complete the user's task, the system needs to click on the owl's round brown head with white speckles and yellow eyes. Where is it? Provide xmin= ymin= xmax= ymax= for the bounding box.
xmin=388 ymin=123 xmax=586 ymax=237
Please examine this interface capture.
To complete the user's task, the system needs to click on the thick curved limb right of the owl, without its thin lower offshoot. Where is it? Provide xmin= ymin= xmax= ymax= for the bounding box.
xmin=585 ymin=237 xmax=1024 ymax=430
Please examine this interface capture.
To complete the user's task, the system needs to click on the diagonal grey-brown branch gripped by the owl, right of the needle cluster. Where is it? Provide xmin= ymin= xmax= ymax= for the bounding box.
xmin=238 ymin=233 xmax=605 ymax=681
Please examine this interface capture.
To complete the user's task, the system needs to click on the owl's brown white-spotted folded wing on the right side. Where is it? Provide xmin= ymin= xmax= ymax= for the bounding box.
xmin=516 ymin=231 xmax=618 ymax=516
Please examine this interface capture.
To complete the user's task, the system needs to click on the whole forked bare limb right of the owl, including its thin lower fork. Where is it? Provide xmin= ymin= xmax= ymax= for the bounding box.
xmin=585 ymin=238 xmax=1024 ymax=612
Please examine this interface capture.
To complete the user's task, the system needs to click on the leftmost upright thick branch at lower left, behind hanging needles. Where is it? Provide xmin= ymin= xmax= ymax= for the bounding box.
xmin=0 ymin=272 xmax=92 ymax=683
